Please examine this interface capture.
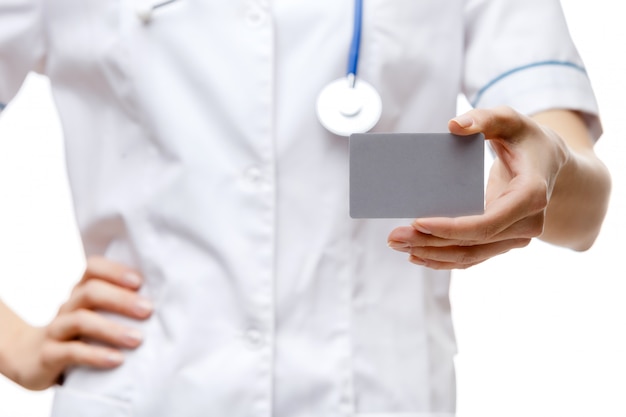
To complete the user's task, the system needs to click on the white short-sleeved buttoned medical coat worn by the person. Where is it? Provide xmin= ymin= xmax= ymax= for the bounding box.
xmin=0 ymin=0 xmax=599 ymax=417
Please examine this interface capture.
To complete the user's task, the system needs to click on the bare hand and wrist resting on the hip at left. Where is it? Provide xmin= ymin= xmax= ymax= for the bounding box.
xmin=0 ymin=257 xmax=153 ymax=390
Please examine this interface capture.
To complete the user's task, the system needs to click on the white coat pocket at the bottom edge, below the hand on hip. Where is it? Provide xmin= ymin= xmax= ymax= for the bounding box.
xmin=51 ymin=387 xmax=133 ymax=417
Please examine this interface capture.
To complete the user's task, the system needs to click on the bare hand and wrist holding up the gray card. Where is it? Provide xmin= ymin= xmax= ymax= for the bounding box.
xmin=388 ymin=107 xmax=611 ymax=269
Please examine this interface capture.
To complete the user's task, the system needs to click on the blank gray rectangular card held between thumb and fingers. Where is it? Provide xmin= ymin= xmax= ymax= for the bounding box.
xmin=350 ymin=133 xmax=485 ymax=218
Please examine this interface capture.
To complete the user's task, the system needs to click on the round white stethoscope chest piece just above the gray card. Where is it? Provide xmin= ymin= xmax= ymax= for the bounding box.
xmin=317 ymin=77 xmax=382 ymax=136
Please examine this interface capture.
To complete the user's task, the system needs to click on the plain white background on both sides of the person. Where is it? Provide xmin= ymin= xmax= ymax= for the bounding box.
xmin=0 ymin=0 xmax=626 ymax=417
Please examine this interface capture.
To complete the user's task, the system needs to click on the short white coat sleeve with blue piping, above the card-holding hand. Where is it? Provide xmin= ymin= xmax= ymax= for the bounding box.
xmin=463 ymin=0 xmax=602 ymax=139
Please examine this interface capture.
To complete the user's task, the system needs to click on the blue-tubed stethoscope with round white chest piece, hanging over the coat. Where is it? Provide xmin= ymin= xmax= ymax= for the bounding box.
xmin=137 ymin=0 xmax=382 ymax=136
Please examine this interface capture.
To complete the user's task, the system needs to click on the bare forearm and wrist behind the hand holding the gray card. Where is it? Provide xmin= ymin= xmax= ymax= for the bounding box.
xmin=535 ymin=111 xmax=611 ymax=251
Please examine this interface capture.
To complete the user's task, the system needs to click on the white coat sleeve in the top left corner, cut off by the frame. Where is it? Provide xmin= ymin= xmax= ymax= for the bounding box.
xmin=0 ymin=0 xmax=46 ymax=111
